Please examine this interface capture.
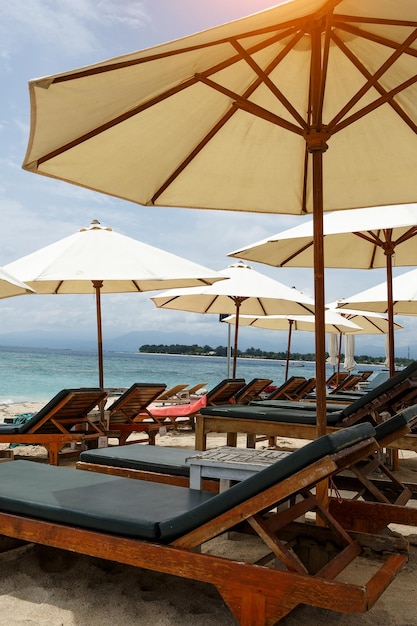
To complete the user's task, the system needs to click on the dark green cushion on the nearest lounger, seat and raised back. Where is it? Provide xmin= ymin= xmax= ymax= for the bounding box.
xmin=0 ymin=424 xmax=375 ymax=542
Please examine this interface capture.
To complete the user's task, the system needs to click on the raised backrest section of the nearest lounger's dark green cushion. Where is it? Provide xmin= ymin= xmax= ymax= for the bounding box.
xmin=160 ymin=423 xmax=375 ymax=541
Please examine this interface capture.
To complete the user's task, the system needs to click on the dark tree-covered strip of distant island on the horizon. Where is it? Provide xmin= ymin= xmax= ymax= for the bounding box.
xmin=139 ymin=343 xmax=412 ymax=366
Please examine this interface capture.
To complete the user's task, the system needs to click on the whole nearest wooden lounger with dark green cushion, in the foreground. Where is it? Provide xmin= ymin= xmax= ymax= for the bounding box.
xmin=0 ymin=424 xmax=408 ymax=626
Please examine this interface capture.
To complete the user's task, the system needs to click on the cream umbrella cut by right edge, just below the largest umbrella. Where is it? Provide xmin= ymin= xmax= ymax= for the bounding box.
xmin=229 ymin=204 xmax=417 ymax=376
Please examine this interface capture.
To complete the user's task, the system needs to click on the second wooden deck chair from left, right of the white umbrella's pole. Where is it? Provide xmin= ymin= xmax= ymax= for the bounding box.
xmin=106 ymin=383 xmax=166 ymax=445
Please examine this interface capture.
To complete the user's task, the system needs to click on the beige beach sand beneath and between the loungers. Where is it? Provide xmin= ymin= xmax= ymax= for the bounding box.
xmin=0 ymin=403 xmax=417 ymax=626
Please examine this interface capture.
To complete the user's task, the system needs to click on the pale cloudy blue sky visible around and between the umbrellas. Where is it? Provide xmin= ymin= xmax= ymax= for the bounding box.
xmin=0 ymin=0 xmax=417 ymax=357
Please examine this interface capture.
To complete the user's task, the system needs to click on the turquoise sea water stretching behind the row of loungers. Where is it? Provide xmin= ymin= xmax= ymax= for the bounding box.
xmin=0 ymin=347 xmax=376 ymax=404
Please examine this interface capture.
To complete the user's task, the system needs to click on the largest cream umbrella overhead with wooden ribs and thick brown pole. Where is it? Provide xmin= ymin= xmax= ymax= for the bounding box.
xmin=23 ymin=0 xmax=417 ymax=435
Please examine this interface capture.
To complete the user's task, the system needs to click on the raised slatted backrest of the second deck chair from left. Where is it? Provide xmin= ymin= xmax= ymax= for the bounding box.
xmin=108 ymin=383 xmax=166 ymax=423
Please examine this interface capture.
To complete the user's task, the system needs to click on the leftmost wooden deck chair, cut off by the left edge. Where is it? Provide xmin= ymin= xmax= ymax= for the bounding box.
xmin=0 ymin=388 xmax=106 ymax=465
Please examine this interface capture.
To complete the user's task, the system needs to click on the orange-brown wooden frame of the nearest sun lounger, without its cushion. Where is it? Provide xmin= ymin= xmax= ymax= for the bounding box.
xmin=0 ymin=438 xmax=408 ymax=626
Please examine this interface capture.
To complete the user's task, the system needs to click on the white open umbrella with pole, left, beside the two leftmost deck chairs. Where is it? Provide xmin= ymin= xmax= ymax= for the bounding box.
xmin=5 ymin=220 xmax=224 ymax=387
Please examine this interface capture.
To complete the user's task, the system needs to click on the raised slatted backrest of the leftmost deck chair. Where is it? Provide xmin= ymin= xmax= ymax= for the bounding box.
xmin=9 ymin=387 xmax=106 ymax=434
